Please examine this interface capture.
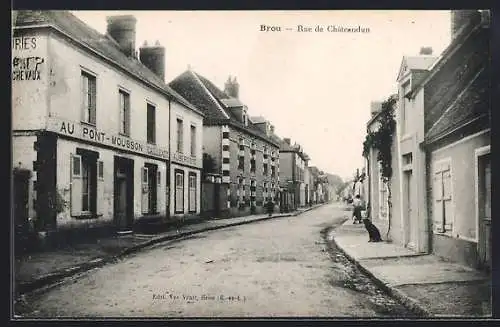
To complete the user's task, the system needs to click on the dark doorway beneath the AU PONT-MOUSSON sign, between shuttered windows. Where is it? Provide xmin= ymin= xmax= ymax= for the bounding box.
xmin=113 ymin=156 xmax=134 ymax=231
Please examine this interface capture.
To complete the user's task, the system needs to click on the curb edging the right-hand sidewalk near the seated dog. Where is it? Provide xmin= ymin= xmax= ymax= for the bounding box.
xmin=332 ymin=233 xmax=433 ymax=317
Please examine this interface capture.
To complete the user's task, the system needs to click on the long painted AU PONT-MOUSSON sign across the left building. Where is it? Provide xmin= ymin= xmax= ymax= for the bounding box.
xmin=47 ymin=117 xmax=168 ymax=160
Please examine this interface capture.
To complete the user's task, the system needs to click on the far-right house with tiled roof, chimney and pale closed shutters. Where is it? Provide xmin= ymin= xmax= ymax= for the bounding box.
xmin=418 ymin=10 xmax=495 ymax=270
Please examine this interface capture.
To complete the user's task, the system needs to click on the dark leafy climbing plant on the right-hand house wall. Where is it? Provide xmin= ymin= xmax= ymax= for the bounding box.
xmin=363 ymin=96 xmax=396 ymax=238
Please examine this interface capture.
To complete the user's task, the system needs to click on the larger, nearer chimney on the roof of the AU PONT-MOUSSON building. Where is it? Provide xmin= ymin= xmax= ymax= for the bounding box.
xmin=106 ymin=15 xmax=137 ymax=57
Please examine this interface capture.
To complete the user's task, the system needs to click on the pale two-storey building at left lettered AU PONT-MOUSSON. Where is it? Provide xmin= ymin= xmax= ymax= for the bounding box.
xmin=12 ymin=11 xmax=203 ymax=238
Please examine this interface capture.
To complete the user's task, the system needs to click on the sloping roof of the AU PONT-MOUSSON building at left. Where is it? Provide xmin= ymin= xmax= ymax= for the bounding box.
xmin=15 ymin=10 xmax=203 ymax=115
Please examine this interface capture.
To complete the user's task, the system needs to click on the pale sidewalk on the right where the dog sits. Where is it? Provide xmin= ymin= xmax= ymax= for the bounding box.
xmin=331 ymin=219 xmax=492 ymax=317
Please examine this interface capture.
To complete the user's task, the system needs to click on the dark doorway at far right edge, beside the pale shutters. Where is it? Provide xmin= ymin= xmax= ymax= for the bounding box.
xmin=478 ymin=154 xmax=492 ymax=271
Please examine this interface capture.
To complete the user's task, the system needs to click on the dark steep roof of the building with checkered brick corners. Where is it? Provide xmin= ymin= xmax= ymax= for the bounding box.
xmin=169 ymin=69 xmax=279 ymax=146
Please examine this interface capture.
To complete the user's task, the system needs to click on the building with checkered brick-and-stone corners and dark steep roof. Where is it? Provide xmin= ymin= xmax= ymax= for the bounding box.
xmin=169 ymin=69 xmax=280 ymax=216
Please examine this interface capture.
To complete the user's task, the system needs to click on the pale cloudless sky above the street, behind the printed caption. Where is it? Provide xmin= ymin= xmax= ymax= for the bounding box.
xmin=73 ymin=10 xmax=450 ymax=180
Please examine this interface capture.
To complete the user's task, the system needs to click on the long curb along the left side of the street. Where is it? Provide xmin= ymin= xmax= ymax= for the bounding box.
xmin=16 ymin=205 xmax=323 ymax=296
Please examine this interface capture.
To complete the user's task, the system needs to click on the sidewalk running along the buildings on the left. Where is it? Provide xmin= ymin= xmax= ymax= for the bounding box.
xmin=14 ymin=204 xmax=321 ymax=294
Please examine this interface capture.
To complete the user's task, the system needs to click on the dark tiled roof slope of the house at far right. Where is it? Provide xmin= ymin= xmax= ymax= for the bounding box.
xmin=425 ymin=69 xmax=491 ymax=142
